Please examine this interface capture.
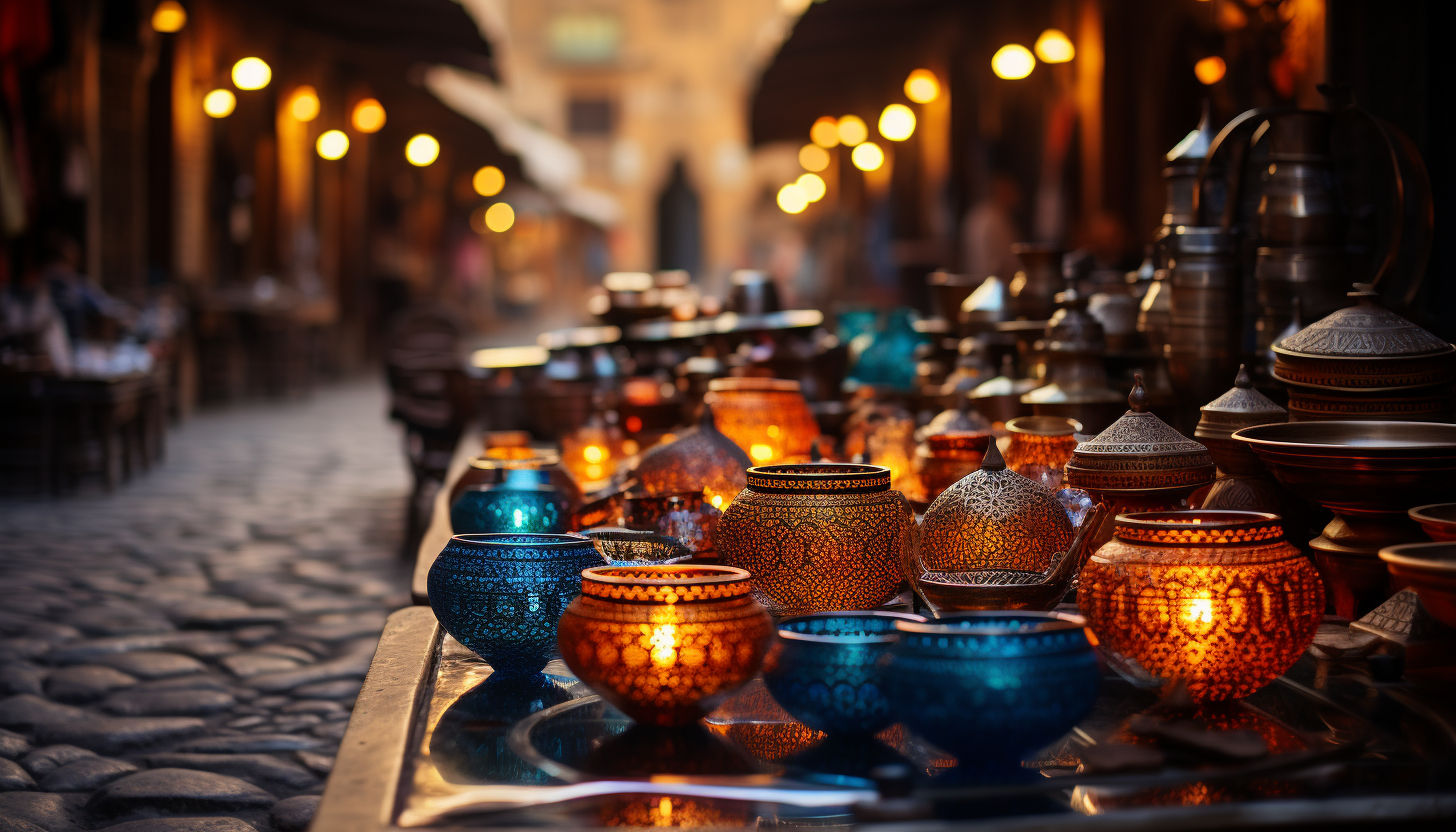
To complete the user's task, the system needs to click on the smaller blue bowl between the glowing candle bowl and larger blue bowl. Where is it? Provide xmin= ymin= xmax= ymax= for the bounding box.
xmin=763 ymin=612 xmax=925 ymax=734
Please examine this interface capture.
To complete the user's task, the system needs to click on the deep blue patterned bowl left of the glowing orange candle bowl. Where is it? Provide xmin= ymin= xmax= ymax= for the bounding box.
xmin=428 ymin=535 xmax=606 ymax=675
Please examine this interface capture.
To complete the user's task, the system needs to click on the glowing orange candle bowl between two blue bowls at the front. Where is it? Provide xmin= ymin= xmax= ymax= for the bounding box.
xmin=558 ymin=565 xmax=773 ymax=726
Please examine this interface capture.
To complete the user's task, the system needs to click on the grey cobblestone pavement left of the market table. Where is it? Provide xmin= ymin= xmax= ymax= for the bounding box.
xmin=0 ymin=385 xmax=409 ymax=832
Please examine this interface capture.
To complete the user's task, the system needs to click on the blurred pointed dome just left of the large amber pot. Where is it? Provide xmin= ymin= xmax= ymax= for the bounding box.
xmin=632 ymin=405 xmax=750 ymax=509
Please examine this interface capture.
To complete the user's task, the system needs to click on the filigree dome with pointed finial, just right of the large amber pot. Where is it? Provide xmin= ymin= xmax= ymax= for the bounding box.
xmin=920 ymin=444 xmax=1072 ymax=573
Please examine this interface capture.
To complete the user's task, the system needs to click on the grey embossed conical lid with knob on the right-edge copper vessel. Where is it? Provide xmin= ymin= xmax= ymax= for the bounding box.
xmin=1274 ymin=283 xmax=1456 ymax=358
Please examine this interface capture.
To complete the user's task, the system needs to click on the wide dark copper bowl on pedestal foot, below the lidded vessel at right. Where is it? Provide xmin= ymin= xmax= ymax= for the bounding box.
xmin=1233 ymin=421 xmax=1456 ymax=618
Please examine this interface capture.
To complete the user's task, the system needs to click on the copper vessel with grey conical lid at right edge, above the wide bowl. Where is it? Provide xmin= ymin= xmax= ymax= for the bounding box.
xmin=1274 ymin=284 xmax=1456 ymax=421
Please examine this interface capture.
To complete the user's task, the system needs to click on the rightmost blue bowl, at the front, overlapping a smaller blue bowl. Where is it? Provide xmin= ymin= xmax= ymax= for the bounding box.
xmin=885 ymin=611 xmax=1101 ymax=768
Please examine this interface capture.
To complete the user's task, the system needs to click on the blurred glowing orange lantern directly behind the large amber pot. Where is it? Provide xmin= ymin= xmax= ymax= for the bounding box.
xmin=705 ymin=377 xmax=818 ymax=465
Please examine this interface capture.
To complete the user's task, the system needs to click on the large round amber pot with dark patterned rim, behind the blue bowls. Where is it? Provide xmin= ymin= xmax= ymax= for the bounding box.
xmin=718 ymin=462 xmax=914 ymax=615
